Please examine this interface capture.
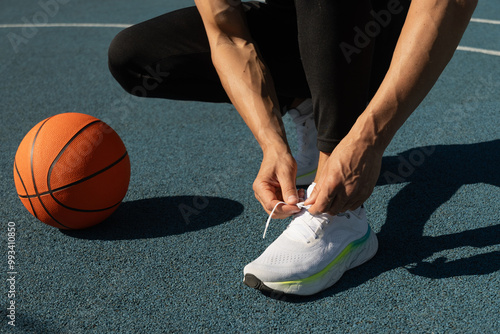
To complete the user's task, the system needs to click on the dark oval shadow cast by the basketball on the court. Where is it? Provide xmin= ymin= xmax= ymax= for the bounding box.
xmin=61 ymin=196 xmax=243 ymax=240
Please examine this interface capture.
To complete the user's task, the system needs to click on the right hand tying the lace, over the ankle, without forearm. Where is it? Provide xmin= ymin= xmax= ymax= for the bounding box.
xmin=304 ymin=136 xmax=383 ymax=215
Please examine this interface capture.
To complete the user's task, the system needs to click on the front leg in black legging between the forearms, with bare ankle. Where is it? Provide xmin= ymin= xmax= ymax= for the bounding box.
xmin=297 ymin=0 xmax=410 ymax=183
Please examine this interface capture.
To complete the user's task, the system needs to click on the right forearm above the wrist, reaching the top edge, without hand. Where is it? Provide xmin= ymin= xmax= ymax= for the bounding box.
xmin=350 ymin=0 xmax=477 ymax=150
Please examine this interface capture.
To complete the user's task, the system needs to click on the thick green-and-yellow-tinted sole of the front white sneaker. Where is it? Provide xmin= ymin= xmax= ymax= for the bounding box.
xmin=243 ymin=227 xmax=378 ymax=296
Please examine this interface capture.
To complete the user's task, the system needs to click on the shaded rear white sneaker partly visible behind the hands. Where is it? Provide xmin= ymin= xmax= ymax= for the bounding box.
xmin=287 ymin=99 xmax=319 ymax=186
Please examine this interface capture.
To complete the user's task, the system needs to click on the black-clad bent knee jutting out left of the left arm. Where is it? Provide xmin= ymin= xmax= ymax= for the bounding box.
xmin=108 ymin=7 xmax=229 ymax=102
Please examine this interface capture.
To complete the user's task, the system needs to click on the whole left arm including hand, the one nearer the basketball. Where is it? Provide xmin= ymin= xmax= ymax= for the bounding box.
xmin=195 ymin=0 xmax=298 ymax=218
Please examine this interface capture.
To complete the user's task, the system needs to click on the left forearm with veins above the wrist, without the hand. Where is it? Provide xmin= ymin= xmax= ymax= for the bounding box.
xmin=196 ymin=0 xmax=288 ymax=150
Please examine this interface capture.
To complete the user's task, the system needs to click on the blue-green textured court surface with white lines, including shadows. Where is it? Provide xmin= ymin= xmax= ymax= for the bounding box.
xmin=0 ymin=0 xmax=500 ymax=334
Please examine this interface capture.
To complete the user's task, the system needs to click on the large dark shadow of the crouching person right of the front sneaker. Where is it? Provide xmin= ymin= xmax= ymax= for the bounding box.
xmin=270 ymin=140 xmax=500 ymax=303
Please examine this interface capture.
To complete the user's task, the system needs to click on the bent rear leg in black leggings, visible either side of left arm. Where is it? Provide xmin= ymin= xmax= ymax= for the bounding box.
xmin=109 ymin=3 xmax=309 ymax=109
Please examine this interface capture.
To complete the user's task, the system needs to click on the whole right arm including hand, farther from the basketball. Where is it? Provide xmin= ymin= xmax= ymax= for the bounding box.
xmin=306 ymin=0 xmax=477 ymax=214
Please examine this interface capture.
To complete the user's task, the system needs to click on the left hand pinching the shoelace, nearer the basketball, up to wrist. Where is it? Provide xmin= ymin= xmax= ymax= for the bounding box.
xmin=253 ymin=150 xmax=304 ymax=218
